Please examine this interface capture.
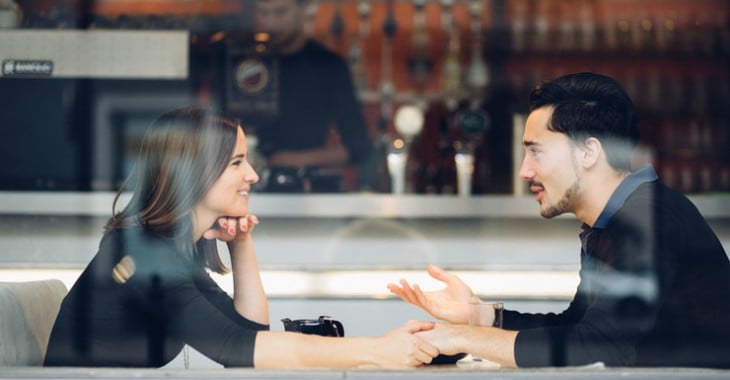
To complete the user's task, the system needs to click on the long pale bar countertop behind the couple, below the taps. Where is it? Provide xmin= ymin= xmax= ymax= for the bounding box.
xmin=0 ymin=191 xmax=730 ymax=219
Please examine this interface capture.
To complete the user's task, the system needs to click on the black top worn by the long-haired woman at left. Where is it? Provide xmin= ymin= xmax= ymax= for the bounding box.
xmin=44 ymin=228 xmax=268 ymax=367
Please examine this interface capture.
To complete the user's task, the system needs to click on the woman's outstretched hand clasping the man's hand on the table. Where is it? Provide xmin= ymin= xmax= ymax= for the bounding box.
xmin=373 ymin=321 xmax=439 ymax=368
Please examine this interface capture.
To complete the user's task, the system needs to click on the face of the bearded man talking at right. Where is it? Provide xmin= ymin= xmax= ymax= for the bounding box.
xmin=519 ymin=107 xmax=581 ymax=218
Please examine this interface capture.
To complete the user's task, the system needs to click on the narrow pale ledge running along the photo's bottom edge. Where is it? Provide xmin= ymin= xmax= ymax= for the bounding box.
xmin=0 ymin=365 xmax=730 ymax=380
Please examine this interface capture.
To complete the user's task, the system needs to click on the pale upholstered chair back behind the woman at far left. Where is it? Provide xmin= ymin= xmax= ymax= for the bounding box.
xmin=0 ymin=280 xmax=68 ymax=367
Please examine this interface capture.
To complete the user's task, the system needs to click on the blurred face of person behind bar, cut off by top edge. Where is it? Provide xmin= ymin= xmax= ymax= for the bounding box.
xmin=256 ymin=0 xmax=304 ymax=48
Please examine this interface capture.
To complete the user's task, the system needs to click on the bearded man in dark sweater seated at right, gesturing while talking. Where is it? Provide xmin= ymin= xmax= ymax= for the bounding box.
xmin=388 ymin=73 xmax=730 ymax=368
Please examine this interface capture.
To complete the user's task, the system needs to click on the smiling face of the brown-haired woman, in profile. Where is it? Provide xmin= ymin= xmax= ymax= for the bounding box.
xmin=196 ymin=128 xmax=259 ymax=219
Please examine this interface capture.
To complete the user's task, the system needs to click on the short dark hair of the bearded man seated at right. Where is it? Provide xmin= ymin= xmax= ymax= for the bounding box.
xmin=530 ymin=72 xmax=639 ymax=170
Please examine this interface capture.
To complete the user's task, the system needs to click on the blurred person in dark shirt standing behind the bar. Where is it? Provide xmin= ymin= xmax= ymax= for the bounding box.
xmin=249 ymin=0 xmax=372 ymax=190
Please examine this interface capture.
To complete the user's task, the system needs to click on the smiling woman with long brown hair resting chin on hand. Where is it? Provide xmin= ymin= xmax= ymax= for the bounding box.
xmin=45 ymin=108 xmax=438 ymax=368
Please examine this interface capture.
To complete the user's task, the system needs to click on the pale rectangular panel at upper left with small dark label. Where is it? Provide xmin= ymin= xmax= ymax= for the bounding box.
xmin=0 ymin=30 xmax=189 ymax=79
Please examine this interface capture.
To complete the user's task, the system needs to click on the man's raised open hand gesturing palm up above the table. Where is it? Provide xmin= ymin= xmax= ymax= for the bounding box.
xmin=388 ymin=265 xmax=479 ymax=324
